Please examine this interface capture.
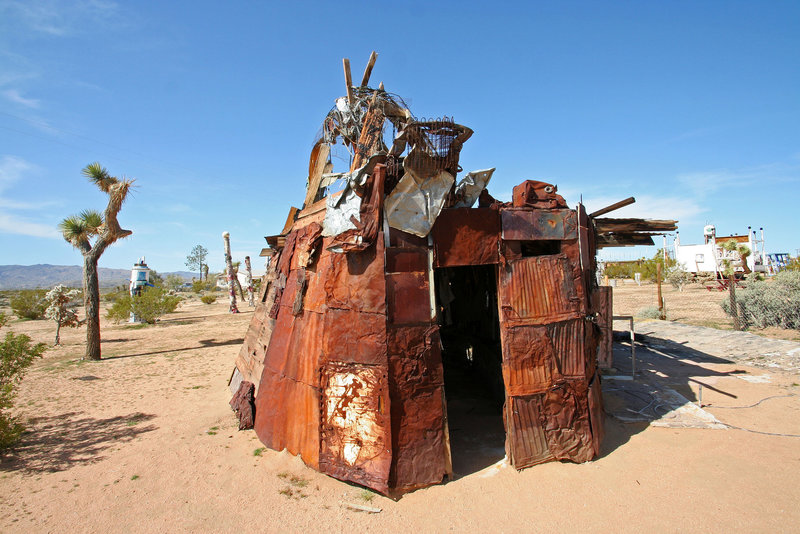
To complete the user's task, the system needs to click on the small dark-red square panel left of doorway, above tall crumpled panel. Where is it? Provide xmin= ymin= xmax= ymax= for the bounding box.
xmin=386 ymin=273 xmax=431 ymax=325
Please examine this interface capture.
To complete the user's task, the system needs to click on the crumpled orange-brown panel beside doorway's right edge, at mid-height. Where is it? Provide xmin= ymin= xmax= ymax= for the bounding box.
xmin=500 ymin=326 xmax=558 ymax=396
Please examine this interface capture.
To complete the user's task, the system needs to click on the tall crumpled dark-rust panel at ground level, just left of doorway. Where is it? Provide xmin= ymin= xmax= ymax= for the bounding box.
xmin=388 ymin=325 xmax=446 ymax=490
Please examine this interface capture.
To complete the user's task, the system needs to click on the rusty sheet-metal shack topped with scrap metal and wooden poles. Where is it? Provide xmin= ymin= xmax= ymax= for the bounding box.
xmin=231 ymin=53 xmax=674 ymax=493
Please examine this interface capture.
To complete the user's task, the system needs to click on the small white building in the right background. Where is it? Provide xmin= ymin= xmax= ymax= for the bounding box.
xmin=675 ymin=224 xmax=769 ymax=276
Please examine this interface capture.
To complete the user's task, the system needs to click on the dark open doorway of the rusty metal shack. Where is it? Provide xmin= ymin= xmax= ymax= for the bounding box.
xmin=435 ymin=265 xmax=505 ymax=476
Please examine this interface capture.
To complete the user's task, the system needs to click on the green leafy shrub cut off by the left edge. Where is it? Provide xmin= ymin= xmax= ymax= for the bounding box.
xmin=0 ymin=313 xmax=46 ymax=451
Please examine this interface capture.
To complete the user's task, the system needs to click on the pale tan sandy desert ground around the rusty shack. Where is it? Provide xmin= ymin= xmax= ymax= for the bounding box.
xmin=0 ymin=301 xmax=800 ymax=533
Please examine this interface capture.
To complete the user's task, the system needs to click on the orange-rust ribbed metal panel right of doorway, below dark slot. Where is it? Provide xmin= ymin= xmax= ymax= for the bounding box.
xmin=499 ymin=254 xmax=580 ymax=324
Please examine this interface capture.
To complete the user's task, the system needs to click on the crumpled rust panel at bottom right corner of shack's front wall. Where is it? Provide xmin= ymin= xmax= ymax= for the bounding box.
xmin=542 ymin=381 xmax=594 ymax=463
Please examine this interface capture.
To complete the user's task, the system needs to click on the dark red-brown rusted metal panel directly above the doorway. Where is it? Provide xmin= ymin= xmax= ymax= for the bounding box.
xmin=432 ymin=208 xmax=500 ymax=267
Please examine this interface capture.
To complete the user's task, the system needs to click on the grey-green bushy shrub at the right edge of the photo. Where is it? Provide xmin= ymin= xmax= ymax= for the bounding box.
xmin=721 ymin=271 xmax=800 ymax=330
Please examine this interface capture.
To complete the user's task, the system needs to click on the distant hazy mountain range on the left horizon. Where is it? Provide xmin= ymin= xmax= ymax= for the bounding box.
xmin=0 ymin=264 xmax=198 ymax=290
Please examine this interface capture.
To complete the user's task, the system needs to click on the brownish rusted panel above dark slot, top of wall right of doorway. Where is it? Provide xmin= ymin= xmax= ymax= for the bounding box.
xmin=500 ymin=208 xmax=578 ymax=241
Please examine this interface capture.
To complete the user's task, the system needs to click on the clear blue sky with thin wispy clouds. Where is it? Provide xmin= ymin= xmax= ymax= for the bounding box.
xmin=0 ymin=0 xmax=800 ymax=272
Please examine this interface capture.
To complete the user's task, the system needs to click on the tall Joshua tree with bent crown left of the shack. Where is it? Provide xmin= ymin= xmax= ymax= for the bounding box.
xmin=58 ymin=162 xmax=133 ymax=360
